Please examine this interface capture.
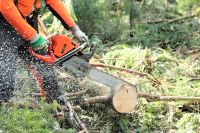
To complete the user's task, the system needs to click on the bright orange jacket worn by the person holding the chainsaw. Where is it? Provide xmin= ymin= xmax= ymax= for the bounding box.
xmin=0 ymin=0 xmax=75 ymax=41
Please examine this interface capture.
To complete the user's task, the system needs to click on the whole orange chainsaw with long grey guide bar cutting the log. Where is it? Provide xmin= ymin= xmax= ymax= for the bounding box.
xmin=29 ymin=34 xmax=137 ymax=130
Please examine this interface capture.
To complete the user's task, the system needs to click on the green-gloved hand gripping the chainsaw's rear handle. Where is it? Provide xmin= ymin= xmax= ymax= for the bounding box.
xmin=30 ymin=34 xmax=49 ymax=55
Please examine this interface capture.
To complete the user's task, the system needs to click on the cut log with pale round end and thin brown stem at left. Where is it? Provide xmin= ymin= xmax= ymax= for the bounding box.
xmin=84 ymin=84 xmax=137 ymax=113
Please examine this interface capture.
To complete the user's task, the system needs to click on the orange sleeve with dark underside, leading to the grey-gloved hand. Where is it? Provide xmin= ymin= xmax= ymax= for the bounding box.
xmin=45 ymin=0 xmax=75 ymax=29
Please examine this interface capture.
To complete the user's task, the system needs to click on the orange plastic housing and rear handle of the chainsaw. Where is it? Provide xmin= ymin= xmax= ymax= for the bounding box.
xmin=29 ymin=34 xmax=79 ymax=64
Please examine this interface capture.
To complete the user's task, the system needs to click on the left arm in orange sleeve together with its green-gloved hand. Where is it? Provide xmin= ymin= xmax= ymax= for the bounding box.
xmin=0 ymin=0 xmax=48 ymax=54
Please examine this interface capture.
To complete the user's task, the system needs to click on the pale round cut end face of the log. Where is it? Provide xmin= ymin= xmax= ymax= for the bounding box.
xmin=112 ymin=84 xmax=138 ymax=113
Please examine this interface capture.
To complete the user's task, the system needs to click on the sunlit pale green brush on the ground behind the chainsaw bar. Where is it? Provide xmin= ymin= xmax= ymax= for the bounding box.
xmin=103 ymin=44 xmax=200 ymax=96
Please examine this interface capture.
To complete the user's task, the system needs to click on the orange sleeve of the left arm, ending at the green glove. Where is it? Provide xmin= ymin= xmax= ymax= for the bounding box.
xmin=0 ymin=0 xmax=36 ymax=41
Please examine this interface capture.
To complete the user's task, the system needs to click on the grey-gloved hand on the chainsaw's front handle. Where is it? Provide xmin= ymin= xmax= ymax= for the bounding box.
xmin=70 ymin=24 xmax=88 ymax=43
